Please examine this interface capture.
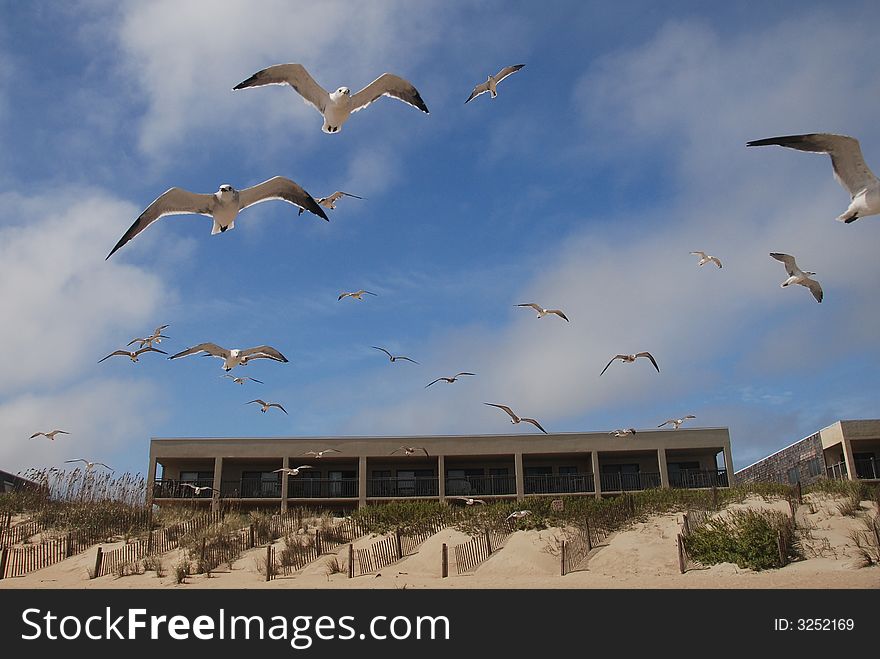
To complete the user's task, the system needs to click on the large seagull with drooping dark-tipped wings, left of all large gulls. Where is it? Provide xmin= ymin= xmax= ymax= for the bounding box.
xmin=107 ymin=176 xmax=330 ymax=259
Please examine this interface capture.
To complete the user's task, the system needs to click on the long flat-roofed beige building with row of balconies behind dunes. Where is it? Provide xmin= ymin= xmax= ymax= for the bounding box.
xmin=148 ymin=428 xmax=733 ymax=510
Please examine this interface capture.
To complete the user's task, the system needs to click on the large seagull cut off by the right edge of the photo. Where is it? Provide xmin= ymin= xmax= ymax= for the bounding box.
xmin=746 ymin=133 xmax=880 ymax=224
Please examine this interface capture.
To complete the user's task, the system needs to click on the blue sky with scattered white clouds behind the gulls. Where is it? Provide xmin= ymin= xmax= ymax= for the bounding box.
xmin=0 ymin=0 xmax=880 ymax=472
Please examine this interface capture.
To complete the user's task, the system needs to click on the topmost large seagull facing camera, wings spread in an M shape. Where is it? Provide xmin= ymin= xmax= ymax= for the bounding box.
xmin=232 ymin=64 xmax=428 ymax=133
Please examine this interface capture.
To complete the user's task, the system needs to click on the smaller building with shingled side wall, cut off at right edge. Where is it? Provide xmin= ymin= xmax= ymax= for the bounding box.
xmin=734 ymin=419 xmax=880 ymax=485
